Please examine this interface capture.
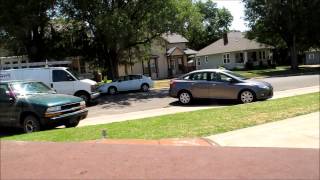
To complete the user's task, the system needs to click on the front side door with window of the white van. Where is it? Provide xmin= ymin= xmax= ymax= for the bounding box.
xmin=50 ymin=69 xmax=76 ymax=95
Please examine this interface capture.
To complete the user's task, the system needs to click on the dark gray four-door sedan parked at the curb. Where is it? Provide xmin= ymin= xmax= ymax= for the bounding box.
xmin=169 ymin=69 xmax=273 ymax=104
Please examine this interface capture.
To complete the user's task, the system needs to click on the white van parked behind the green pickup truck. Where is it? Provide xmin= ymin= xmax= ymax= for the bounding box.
xmin=0 ymin=67 xmax=99 ymax=102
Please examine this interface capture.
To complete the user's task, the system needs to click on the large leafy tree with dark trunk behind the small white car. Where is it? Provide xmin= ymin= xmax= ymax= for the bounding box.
xmin=61 ymin=0 xmax=200 ymax=78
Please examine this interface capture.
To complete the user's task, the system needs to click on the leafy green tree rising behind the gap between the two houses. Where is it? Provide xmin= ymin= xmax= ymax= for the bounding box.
xmin=186 ymin=0 xmax=233 ymax=49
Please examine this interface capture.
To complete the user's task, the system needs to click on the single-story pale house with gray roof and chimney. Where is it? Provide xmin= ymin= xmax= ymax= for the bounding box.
xmin=196 ymin=32 xmax=273 ymax=69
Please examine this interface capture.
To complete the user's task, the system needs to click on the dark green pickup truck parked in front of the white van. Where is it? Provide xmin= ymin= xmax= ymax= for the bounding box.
xmin=0 ymin=81 xmax=88 ymax=133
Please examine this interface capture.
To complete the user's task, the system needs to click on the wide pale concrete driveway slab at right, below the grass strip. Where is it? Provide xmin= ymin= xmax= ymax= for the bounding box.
xmin=207 ymin=112 xmax=320 ymax=148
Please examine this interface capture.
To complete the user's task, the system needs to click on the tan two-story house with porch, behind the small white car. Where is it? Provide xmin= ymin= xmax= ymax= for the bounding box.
xmin=119 ymin=33 xmax=198 ymax=79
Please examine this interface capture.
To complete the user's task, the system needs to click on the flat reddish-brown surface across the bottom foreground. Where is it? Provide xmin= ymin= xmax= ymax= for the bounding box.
xmin=0 ymin=141 xmax=319 ymax=179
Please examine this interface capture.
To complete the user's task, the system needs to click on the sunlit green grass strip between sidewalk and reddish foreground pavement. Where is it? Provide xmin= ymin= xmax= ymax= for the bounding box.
xmin=2 ymin=93 xmax=320 ymax=141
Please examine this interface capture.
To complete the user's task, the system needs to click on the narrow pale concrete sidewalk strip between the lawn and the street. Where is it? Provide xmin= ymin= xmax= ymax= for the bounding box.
xmin=79 ymin=86 xmax=320 ymax=126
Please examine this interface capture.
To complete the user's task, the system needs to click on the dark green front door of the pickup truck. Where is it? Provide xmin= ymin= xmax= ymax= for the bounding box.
xmin=0 ymin=84 xmax=18 ymax=125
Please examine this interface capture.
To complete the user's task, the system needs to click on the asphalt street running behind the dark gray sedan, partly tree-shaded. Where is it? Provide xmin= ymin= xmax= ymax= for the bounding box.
xmin=89 ymin=75 xmax=320 ymax=117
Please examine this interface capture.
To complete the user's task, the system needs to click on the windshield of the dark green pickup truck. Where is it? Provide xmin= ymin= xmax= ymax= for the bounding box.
xmin=12 ymin=82 xmax=54 ymax=95
